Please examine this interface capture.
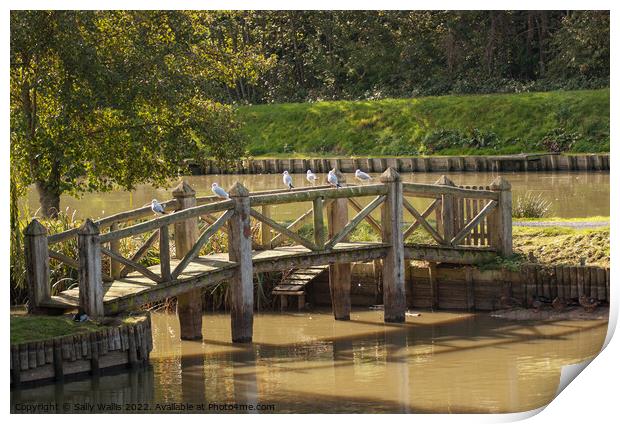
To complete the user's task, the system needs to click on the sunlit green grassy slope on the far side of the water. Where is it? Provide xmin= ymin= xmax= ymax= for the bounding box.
xmin=239 ymin=89 xmax=609 ymax=157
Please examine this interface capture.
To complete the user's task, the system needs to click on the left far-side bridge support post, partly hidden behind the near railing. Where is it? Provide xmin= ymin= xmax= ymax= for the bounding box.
xmin=172 ymin=181 xmax=202 ymax=340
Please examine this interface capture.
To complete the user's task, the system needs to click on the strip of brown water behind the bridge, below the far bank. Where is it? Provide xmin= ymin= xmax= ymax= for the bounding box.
xmin=27 ymin=172 xmax=609 ymax=220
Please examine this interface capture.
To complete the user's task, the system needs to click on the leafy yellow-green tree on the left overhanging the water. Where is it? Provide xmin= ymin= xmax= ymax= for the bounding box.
xmin=11 ymin=11 xmax=269 ymax=216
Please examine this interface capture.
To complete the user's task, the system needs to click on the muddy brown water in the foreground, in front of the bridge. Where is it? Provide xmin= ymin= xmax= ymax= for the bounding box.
xmin=11 ymin=310 xmax=607 ymax=413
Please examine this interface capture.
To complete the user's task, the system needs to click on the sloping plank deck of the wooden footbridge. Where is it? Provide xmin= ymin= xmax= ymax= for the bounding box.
xmin=44 ymin=243 xmax=386 ymax=314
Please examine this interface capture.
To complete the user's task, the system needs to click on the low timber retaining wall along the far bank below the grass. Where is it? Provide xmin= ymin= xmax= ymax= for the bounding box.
xmin=189 ymin=153 xmax=610 ymax=175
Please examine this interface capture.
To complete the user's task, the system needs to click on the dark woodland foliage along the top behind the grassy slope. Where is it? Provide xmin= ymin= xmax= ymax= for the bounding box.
xmin=191 ymin=10 xmax=609 ymax=103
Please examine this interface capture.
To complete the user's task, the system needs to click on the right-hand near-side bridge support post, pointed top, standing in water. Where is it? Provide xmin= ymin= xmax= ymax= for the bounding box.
xmin=381 ymin=167 xmax=407 ymax=322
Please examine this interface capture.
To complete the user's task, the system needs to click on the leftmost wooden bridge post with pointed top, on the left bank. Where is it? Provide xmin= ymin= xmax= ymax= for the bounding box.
xmin=24 ymin=219 xmax=50 ymax=313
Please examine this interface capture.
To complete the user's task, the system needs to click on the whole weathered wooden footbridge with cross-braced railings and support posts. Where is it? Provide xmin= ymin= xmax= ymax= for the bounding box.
xmin=25 ymin=168 xmax=512 ymax=342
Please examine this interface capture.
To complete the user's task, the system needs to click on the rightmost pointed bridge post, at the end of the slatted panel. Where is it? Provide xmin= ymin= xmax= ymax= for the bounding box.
xmin=489 ymin=176 xmax=512 ymax=256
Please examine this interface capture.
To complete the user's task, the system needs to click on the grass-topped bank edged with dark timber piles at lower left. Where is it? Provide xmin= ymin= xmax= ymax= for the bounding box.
xmin=10 ymin=313 xmax=153 ymax=386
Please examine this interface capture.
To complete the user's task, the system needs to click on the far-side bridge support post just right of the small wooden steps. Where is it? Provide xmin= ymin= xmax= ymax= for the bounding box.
xmin=327 ymin=169 xmax=351 ymax=320
